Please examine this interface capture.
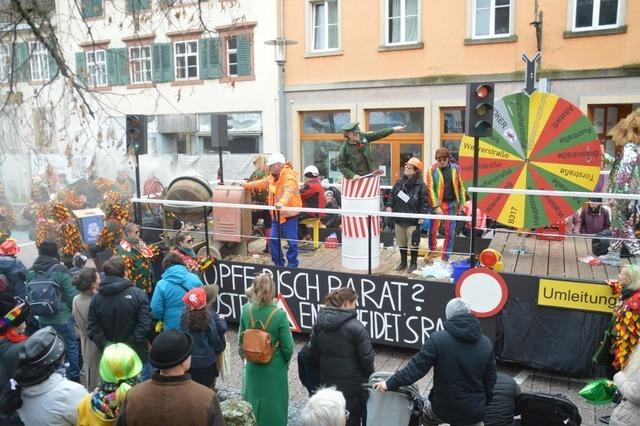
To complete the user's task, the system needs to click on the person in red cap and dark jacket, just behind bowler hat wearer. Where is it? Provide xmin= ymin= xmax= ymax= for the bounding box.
xmin=180 ymin=286 xmax=227 ymax=388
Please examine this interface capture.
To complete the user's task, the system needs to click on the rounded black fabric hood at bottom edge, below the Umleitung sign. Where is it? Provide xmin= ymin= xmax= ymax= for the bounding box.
xmin=518 ymin=392 xmax=582 ymax=426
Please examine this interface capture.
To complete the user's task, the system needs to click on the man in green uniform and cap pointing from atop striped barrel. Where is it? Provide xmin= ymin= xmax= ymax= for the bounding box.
xmin=338 ymin=121 xmax=407 ymax=180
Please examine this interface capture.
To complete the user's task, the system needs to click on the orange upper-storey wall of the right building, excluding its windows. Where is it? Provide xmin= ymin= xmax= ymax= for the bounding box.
xmin=284 ymin=0 xmax=640 ymax=85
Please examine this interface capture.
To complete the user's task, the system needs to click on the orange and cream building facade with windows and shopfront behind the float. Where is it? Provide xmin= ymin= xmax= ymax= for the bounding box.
xmin=284 ymin=0 xmax=640 ymax=184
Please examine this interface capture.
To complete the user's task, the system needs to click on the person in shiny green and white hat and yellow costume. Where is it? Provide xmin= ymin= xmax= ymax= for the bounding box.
xmin=76 ymin=343 xmax=142 ymax=426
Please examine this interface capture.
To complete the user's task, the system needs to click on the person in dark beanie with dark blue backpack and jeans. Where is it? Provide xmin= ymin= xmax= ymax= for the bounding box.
xmin=27 ymin=240 xmax=80 ymax=382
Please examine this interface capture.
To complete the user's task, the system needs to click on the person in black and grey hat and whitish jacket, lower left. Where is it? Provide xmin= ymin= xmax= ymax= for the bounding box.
xmin=3 ymin=327 xmax=87 ymax=425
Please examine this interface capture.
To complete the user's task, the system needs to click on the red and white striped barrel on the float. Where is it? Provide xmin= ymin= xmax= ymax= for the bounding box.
xmin=342 ymin=176 xmax=380 ymax=271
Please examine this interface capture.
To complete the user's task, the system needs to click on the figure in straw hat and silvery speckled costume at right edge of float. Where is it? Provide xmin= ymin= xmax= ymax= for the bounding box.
xmin=600 ymin=109 xmax=640 ymax=266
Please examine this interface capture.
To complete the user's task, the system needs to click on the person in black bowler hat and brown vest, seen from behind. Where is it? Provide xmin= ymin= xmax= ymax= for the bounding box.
xmin=117 ymin=330 xmax=225 ymax=426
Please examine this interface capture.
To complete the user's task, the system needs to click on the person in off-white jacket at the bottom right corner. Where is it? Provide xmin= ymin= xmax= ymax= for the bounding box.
xmin=609 ymin=346 xmax=640 ymax=426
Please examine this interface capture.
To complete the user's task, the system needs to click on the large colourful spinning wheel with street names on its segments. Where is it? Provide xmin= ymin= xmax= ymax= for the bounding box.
xmin=459 ymin=92 xmax=601 ymax=228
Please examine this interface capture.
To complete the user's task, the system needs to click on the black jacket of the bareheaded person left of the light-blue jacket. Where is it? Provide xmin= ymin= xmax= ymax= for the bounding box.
xmin=88 ymin=276 xmax=151 ymax=361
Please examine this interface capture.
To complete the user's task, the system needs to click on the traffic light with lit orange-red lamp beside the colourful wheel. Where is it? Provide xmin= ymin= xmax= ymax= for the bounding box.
xmin=465 ymin=83 xmax=494 ymax=137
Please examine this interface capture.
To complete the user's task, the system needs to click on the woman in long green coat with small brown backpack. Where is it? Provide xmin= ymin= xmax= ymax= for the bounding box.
xmin=238 ymin=273 xmax=294 ymax=426
